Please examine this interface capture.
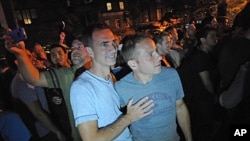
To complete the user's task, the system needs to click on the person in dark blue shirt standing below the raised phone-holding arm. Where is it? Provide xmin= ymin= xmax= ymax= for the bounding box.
xmin=8 ymin=50 xmax=66 ymax=141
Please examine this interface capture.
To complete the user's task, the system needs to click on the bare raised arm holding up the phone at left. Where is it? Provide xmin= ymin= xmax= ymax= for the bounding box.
xmin=4 ymin=34 xmax=48 ymax=87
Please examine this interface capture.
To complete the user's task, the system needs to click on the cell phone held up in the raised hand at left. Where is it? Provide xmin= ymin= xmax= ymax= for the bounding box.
xmin=8 ymin=27 xmax=28 ymax=43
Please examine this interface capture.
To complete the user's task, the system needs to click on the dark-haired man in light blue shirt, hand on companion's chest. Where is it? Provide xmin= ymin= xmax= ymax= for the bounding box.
xmin=70 ymin=24 xmax=153 ymax=141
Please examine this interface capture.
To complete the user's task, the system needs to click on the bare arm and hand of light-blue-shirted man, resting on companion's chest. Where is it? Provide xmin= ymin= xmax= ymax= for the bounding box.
xmin=78 ymin=97 xmax=154 ymax=141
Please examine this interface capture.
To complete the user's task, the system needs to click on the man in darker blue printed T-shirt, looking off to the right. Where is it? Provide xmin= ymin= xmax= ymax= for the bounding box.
xmin=115 ymin=34 xmax=192 ymax=141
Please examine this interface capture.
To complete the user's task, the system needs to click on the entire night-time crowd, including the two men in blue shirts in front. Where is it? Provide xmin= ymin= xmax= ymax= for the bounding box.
xmin=0 ymin=3 xmax=250 ymax=141
